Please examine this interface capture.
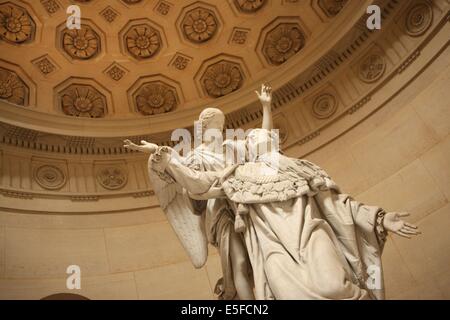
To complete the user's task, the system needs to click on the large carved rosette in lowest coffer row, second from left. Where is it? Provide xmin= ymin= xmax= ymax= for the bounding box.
xmin=59 ymin=84 xmax=107 ymax=118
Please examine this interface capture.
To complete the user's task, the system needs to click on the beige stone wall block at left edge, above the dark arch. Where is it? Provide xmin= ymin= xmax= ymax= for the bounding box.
xmin=5 ymin=227 xmax=109 ymax=278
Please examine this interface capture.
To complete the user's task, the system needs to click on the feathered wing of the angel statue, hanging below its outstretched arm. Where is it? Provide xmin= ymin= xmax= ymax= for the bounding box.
xmin=148 ymin=161 xmax=208 ymax=268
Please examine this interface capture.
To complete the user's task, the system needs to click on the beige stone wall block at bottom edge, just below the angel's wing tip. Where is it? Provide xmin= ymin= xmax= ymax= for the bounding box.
xmin=135 ymin=262 xmax=213 ymax=300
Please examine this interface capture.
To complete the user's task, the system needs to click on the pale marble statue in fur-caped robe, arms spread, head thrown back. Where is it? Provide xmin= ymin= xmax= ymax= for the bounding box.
xmin=125 ymin=85 xmax=420 ymax=299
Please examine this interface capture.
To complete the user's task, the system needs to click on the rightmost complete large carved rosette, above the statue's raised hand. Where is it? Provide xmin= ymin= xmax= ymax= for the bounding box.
xmin=262 ymin=23 xmax=305 ymax=65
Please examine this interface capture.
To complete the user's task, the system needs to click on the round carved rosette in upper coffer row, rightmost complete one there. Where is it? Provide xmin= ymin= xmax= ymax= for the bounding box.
xmin=181 ymin=7 xmax=218 ymax=43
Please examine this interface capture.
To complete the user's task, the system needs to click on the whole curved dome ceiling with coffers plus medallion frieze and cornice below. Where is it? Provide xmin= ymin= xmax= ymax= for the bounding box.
xmin=0 ymin=0 xmax=450 ymax=212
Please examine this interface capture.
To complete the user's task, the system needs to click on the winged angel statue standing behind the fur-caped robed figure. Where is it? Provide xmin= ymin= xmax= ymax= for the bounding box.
xmin=124 ymin=108 xmax=254 ymax=300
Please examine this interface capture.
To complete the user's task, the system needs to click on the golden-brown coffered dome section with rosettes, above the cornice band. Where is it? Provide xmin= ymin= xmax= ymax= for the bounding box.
xmin=0 ymin=0 xmax=354 ymax=137
